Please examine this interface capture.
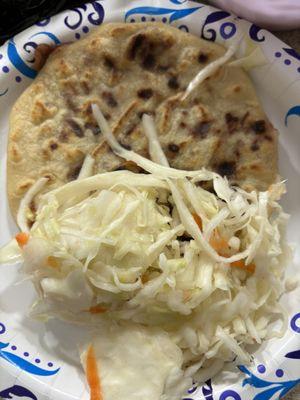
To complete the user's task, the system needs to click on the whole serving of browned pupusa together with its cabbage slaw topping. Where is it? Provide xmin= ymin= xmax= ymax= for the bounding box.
xmin=0 ymin=23 xmax=290 ymax=400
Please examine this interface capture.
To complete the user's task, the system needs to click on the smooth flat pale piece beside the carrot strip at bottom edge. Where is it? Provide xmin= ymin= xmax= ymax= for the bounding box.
xmin=81 ymin=325 xmax=192 ymax=400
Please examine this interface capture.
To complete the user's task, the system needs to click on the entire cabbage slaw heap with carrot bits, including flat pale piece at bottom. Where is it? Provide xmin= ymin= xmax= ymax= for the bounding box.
xmin=0 ymin=104 xmax=289 ymax=400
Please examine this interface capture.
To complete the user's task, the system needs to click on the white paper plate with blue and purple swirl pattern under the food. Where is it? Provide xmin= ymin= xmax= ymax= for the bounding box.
xmin=0 ymin=0 xmax=300 ymax=400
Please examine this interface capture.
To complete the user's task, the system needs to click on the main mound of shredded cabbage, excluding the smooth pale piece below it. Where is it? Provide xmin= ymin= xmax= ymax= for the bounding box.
xmin=2 ymin=160 xmax=288 ymax=388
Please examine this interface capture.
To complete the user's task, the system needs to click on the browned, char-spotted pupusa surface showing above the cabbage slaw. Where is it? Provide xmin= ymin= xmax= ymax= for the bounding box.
xmin=8 ymin=23 xmax=277 ymax=220
